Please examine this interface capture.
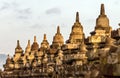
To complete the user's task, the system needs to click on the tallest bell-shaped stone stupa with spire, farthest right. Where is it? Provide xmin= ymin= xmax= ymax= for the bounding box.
xmin=95 ymin=4 xmax=112 ymax=36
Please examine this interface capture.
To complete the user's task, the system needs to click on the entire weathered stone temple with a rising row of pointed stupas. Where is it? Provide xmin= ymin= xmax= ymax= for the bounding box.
xmin=0 ymin=4 xmax=120 ymax=78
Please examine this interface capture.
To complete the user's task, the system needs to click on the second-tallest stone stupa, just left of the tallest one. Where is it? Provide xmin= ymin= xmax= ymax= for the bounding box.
xmin=66 ymin=12 xmax=84 ymax=44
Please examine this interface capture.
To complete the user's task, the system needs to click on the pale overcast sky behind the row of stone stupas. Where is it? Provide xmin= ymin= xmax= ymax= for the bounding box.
xmin=0 ymin=0 xmax=120 ymax=55
